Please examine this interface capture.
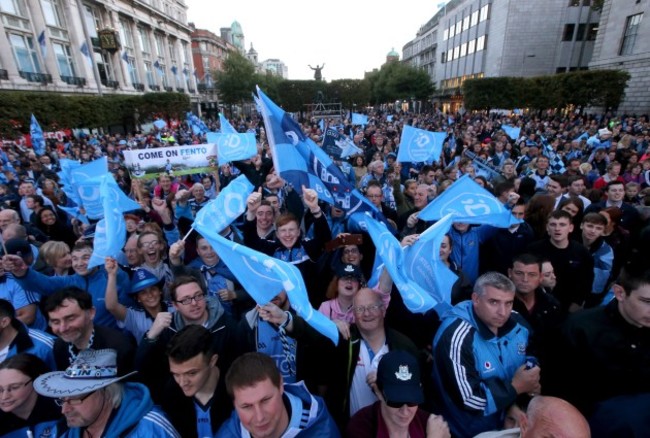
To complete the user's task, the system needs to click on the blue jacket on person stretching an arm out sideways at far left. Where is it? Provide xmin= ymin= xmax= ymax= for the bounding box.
xmin=15 ymin=266 xmax=132 ymax=329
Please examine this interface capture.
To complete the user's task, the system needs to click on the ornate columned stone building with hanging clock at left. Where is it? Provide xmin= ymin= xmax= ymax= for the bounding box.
xmin=0 ymin=0 xmax=196 ymax=94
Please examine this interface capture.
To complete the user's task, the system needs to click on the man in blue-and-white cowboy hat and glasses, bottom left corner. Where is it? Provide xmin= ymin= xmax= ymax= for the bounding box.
xmin=34 ymin=349 xmax=180 ymax=438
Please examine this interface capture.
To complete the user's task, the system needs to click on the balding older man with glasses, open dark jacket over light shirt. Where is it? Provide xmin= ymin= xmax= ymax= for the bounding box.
xmin=324 ymin=288 xmax=418 ymax=426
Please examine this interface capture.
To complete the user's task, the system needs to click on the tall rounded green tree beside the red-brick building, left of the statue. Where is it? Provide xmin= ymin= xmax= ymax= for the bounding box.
xmin=216 ymin=51 xmax=256 ymax=105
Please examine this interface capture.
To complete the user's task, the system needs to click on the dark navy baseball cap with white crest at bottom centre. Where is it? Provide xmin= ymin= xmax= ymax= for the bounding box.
xmin=377 ymin=350 xmax=424 ymax=404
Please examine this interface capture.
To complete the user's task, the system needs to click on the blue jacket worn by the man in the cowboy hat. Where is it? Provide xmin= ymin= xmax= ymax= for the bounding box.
xmin=61 ymin=383 xmax=180 ymax=438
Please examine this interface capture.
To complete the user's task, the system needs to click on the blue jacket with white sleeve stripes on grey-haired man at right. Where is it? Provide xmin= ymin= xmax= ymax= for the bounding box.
xmin=433 ymin=301 xmax=529 ymax=437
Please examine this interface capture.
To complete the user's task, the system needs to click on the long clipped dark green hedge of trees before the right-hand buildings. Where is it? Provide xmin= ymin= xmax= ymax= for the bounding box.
xmin=463 ymin=70 xmax=630 ymax=110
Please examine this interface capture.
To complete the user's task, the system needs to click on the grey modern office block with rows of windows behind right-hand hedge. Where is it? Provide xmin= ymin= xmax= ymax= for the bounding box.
xmin=404 ymin=0 xmax=600 ymax=110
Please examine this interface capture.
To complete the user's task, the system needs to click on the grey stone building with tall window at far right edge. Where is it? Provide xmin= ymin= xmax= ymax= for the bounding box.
xmin=589 ymin=0 xmax=650 ymax=114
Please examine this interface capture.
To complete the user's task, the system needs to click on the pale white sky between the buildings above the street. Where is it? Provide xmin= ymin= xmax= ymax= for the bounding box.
xmin=185 ymin=0 xmax=444 ymax=81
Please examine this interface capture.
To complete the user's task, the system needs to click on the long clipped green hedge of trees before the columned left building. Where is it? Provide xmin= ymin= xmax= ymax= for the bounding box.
xmin=0 ymin=91 xmax=190 ymax=138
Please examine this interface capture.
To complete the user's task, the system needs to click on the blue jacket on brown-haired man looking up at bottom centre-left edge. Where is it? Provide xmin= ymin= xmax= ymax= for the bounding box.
xmin=216 ymin=382 xmax=341 ymax=438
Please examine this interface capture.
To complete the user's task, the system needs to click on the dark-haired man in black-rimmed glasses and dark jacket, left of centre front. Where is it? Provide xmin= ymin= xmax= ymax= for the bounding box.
xmin=135 ymin=276 xmax=235 ymax=402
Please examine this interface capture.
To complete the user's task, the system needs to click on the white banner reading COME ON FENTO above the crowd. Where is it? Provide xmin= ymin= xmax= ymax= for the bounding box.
xmin=124 ymin=144 xmax=218 ymax=179
